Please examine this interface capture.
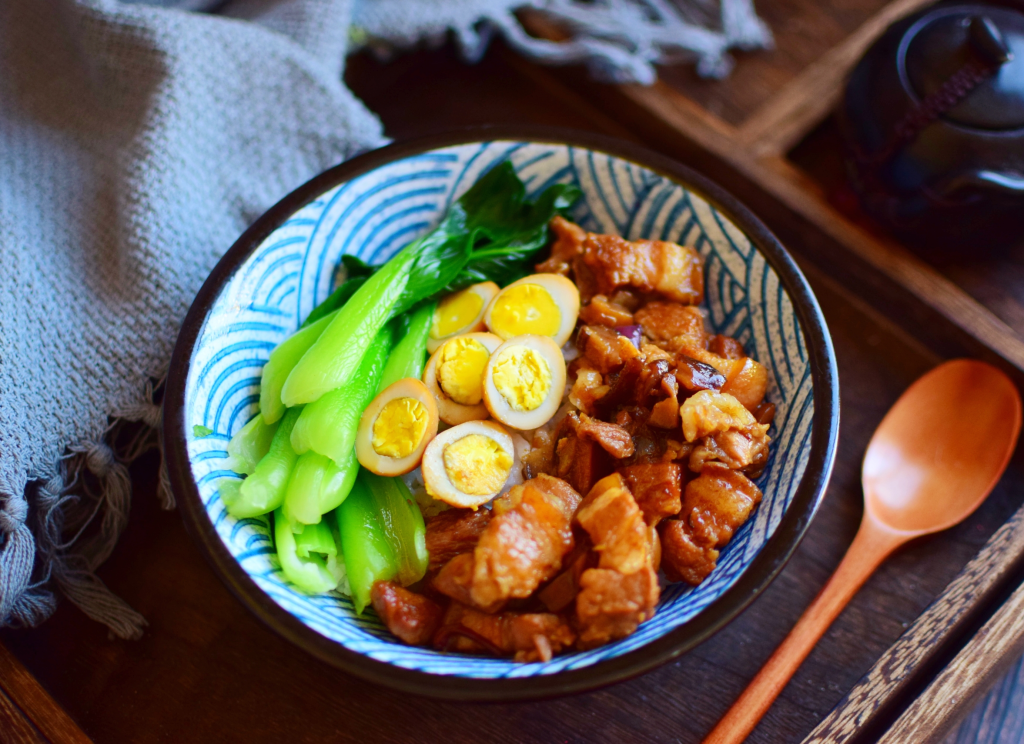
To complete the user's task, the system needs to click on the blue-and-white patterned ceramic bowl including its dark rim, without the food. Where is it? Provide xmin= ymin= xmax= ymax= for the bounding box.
xmin=163 ymin=130 xmax=839 ymax=700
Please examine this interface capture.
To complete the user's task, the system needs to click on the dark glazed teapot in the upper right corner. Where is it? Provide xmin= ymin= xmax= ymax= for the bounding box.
xmin=839 ymin=0 xmax=1024 ymax=250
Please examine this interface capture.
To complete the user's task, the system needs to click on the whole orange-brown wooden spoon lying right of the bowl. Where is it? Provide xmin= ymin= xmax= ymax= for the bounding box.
xmin=705 ymin=359 xmax=1021 ymax=744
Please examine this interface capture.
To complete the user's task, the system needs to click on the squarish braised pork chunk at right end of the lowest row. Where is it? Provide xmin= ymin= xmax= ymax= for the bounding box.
xmin=577 ymin=565 xmax=660 ymax=649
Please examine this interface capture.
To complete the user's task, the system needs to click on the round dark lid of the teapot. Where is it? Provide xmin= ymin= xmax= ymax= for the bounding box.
xmin=899 ymin=4 xmax=1024 ymax=130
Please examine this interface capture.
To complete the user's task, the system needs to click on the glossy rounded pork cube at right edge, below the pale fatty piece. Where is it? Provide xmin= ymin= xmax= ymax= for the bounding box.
xmin=680 ymin=463 xmax=761 ymax=549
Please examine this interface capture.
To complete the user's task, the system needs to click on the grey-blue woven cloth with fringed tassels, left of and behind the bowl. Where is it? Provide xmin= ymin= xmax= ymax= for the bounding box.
xmin=0 ymin=0 xmax=770 ymax=638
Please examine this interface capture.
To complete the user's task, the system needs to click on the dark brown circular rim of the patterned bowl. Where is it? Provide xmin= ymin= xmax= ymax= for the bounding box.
xmin=160 ymin=126 xmax=839 ymax=701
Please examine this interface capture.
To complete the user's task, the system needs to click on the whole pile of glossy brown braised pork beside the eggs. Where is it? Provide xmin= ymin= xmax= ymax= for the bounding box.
xmin=374 ymin=217 xmax=774 ymax=661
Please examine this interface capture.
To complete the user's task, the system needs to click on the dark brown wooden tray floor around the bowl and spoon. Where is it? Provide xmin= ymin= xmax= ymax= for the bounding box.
xmin=0 ymin=37 xmax=1024 ymax=744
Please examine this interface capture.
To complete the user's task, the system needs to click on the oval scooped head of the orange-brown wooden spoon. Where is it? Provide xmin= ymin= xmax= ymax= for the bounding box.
xmin=861 ymin=359 xmax=1021 ymax=536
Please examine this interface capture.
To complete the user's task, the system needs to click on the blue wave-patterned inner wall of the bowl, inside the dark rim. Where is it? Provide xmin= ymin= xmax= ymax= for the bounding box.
xmin=172 ymin=132 xmax=836 ymax=692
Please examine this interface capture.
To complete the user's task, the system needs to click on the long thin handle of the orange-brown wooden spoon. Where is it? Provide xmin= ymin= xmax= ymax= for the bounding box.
xmin=703 ymin=514 xmax=907 ymax=744
